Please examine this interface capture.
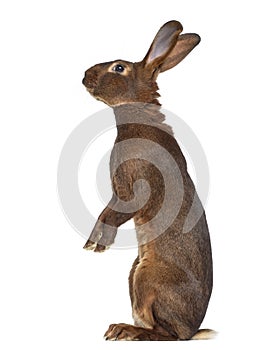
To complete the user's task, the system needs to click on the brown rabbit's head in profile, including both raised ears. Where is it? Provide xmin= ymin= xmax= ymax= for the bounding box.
xmin=83 ymin=21 xmax=200 ymax=107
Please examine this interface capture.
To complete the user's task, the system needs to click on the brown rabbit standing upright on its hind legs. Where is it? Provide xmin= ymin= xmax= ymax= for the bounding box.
xmin=83 ymin=21 xmax=214 ymax=340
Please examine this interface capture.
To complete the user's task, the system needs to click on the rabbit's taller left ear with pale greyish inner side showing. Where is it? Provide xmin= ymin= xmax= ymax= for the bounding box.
xmin=142 ymin=21 xmax=182 ymax=71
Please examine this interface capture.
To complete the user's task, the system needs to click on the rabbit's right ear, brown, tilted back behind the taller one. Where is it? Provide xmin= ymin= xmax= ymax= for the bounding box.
xmin=159 ymin=34 xmax=201 ymax=72
